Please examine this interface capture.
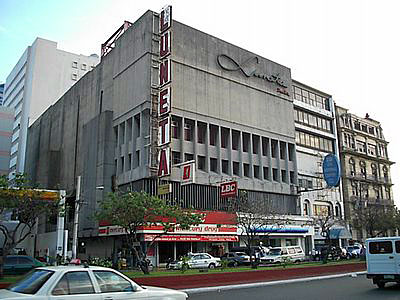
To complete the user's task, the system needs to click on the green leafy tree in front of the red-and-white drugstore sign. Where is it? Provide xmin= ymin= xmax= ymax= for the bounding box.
xmin=95 ymin=191 xmax=203 ymax=274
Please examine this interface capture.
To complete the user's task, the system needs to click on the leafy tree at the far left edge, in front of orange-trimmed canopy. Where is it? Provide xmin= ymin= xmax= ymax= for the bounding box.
xmin=0 ymin=174 xmax=60 ymax=277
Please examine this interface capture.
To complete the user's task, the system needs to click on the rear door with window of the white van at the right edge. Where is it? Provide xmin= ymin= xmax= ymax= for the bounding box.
xmin=368 ymin=240 xmax=397 ymax=274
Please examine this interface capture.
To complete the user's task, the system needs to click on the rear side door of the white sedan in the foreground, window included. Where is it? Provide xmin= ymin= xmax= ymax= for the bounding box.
xmin=49 ymin=271 xmax=103 ymax=300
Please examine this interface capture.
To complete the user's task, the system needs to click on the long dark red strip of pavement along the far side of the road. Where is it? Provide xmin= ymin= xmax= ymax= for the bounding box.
xmin=133 ymin=262 xmax=366 ymax=289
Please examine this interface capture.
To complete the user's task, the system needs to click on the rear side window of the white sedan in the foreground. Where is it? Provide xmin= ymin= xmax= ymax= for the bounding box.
xmin=52 ymin=271 xmax=95 ymax=295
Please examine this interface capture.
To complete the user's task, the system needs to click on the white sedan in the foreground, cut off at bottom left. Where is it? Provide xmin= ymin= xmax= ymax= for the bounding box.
xmin=0 ymin=266 xmax=188 ymax=300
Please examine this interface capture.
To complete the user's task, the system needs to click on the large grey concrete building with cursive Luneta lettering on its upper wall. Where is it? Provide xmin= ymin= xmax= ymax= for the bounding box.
xmin=26 ymin=11 xmax=308 ymax=263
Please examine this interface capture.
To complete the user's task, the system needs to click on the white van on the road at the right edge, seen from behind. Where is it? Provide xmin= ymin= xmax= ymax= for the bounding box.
xmin=366 ymin=237 xmax=400 ymax=288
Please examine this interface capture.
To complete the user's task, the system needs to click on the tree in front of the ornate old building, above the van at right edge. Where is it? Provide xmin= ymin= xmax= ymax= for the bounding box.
xmin=352 ymin=203 xmax=398 ymax=237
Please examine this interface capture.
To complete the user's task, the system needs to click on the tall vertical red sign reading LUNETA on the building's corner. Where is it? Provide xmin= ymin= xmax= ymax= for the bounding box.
xmin=158 ymin=5 xmax=172 ymax=177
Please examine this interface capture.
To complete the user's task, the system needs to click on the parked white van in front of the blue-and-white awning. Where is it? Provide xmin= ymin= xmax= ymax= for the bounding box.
xmin=260 ymin=246 xmax=306 ymax=264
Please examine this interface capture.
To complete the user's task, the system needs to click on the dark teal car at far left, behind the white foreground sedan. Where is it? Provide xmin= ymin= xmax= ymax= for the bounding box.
xmin=3 ymin=255 xmax=45 ymax=275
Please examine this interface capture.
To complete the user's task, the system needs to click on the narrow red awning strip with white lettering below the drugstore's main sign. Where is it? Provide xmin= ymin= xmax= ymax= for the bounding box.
xmin=144 ymin=234 xmax=239 ymax=242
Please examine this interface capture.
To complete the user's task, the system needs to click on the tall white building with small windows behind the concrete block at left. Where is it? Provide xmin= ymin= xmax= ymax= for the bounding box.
xmin=3 ymin=38 xmax=99 ymax=176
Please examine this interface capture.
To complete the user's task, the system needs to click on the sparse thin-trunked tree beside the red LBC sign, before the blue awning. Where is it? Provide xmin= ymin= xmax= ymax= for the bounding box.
xmin=228 ymin=191 xmax=288 ymax=267
